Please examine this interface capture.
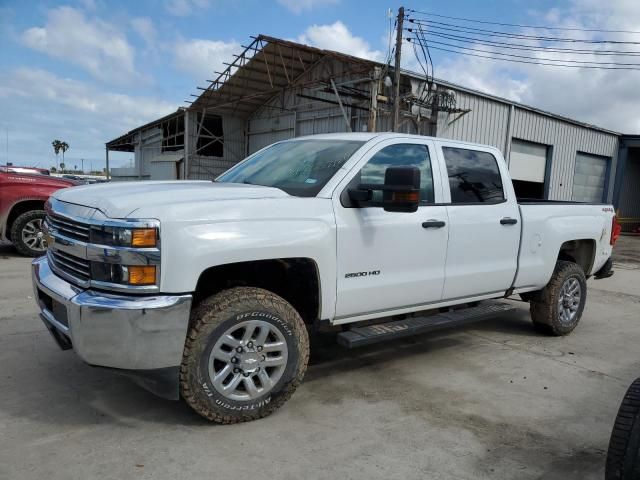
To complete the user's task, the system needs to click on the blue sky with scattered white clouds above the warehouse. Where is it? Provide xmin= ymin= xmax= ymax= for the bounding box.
xmin=0 ymin=0 xmax=640 ymax=168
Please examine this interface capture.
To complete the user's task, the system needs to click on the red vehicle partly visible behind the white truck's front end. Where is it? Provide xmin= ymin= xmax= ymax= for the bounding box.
xmin=0 ymin=166 xmax=77 ymax=257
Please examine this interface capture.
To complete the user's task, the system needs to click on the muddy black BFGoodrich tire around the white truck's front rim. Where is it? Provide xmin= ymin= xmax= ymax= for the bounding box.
xmin=180 ymin=287 xmax=309 ymax=424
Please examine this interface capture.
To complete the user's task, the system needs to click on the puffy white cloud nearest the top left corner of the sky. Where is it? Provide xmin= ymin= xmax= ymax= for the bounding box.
xmin=21 ymin=7 xmax=137 ymax=83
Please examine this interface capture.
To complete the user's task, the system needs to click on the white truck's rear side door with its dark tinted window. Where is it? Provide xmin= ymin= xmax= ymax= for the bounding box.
xmin=437 ymin=142 xmax=520 ymax=300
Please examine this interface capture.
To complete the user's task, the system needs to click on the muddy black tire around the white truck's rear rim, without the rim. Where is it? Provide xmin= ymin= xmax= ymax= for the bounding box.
xmin=530 ymin=260 xmax=587 ymax=336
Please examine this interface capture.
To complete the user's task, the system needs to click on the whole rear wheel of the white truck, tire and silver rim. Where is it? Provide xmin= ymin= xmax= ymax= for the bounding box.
xmin=530 ymin=260 xmax=587 ymax=336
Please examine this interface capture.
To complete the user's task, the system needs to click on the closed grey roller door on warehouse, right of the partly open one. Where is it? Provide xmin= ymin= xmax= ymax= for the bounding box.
xmin=571 ymin=152 xmax=609 ymax=203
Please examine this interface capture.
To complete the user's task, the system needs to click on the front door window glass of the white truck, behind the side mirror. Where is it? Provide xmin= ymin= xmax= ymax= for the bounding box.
xmin=359 ymin=143 xmax=434 ymax=205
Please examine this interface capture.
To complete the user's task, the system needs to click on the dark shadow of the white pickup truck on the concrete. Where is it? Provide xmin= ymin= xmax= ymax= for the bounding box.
xmin=0 ymin=312 xmax=537 ymax=428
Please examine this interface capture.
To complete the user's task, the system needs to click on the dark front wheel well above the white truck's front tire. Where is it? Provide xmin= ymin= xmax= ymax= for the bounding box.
xmin=194 ymin=258 xmax=320 ymax=323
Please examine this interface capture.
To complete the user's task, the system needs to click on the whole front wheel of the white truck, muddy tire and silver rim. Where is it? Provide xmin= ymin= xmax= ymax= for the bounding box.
xmin=180 ymin=287 xmax=309 ymax=423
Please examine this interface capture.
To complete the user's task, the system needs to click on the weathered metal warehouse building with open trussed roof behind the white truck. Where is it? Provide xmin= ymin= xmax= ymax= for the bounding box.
xmin=106 ymin=35 xmax=640 ymax=229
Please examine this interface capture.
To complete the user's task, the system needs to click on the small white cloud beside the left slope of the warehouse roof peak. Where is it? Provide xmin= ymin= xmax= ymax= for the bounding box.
xmin=174 ymin=39 xmax=242 ymax=80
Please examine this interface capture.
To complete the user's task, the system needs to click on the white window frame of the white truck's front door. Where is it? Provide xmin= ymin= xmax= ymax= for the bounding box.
xmin=338 ymin=137 xmax=444 ymax=208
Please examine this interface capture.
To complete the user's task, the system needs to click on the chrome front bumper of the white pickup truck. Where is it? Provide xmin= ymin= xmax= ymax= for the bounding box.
xmin=32 ymin=257 xmax=192 ymax=399
